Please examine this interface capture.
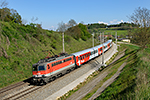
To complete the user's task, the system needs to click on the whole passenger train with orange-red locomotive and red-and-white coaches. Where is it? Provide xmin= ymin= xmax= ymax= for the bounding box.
xmin=32 ymin=40 xmax=112 ymax=84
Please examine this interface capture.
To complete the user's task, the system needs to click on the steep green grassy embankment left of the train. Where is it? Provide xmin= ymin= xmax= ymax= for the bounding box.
xmin=0 ymin=22 xmax=98 ymax=88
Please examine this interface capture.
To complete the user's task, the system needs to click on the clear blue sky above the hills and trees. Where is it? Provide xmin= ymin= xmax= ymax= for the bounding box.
xmin=6 ymin=0 xmax=150 ymax=30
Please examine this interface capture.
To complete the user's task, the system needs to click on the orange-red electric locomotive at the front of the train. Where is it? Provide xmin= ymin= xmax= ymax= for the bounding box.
xmin=32 ymin=56 xmax=75 ymax=83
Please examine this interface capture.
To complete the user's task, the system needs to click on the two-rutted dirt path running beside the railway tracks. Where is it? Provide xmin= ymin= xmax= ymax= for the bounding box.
xmin=67 ymin=49 xmax=126 ymax=100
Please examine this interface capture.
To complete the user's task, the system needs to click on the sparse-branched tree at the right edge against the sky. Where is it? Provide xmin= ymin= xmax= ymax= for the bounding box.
xmin=129 ymin=7 xmax=150 ymax=48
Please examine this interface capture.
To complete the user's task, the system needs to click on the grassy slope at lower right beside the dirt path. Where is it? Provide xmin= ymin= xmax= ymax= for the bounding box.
xmin=96 ymin=45 xmax=150 ymax=100
